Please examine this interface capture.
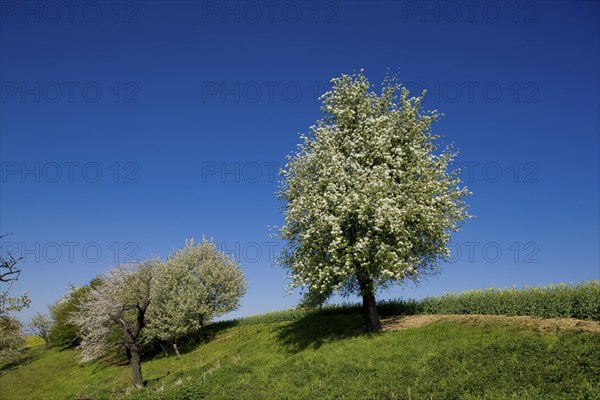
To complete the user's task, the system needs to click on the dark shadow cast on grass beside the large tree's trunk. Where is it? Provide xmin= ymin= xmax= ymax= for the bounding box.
xmin=276 ymin=312 xmax=364 ymax=353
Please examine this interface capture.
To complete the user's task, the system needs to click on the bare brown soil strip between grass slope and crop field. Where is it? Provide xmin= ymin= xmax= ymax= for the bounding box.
xmin=381 ymin=314 xmax=600 ymax=333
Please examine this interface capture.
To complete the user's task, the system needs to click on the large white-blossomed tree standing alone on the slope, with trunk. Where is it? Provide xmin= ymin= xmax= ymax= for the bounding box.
xmin=278 ymin=70 xmax=469 ymax=331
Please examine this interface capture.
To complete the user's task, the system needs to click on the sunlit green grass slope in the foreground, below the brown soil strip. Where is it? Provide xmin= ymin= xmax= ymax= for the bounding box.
xmin=0 ymin=314 xmax=600 ymax=400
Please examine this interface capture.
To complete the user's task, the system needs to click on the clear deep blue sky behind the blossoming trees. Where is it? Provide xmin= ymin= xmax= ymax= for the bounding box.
xmin=0 ymin=1 xmax=600 ymax=320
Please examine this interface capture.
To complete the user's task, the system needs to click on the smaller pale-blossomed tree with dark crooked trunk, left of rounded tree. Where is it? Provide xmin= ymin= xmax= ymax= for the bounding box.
xmin=71 ymin=260 xmax=160 ymax=387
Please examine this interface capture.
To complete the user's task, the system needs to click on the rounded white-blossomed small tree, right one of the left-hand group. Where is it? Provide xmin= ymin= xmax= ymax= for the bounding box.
xmin=146 ymin=239 xmax=246 ymax=356
